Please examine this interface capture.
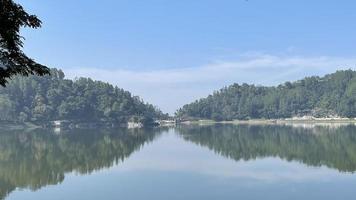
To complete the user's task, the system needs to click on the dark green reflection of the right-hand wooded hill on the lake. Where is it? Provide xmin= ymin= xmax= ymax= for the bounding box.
xmin=178 ymin=125 xmax=356 ymax=173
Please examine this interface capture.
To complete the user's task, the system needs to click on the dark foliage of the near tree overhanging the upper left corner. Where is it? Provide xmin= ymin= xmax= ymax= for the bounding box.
xmin=0 ymin=0 xmax=50 ymax=86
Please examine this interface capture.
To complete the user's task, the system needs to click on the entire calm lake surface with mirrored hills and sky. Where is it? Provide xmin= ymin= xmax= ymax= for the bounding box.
xmin=0 ymin=125 xmax=356 ymax=200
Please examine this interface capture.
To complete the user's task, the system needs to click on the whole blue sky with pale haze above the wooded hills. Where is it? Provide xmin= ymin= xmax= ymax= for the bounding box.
xmin=17 ymin=0 xmax=356 ymax=113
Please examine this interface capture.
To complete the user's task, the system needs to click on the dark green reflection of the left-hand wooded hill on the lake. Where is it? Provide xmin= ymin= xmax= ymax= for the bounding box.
xmin=0 ymin=129 xmax=165 ymax=199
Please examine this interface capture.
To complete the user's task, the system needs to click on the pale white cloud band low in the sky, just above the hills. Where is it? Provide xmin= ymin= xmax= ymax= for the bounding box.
xmin=65 ymin=53 xmax=356 ymax=113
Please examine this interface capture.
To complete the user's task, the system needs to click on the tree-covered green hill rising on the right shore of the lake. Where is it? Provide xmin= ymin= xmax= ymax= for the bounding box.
xmin=177 ymin=70 xmax=356 ymax=120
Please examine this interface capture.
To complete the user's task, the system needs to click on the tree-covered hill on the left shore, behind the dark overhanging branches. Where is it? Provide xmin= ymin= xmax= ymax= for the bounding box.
xmin=0 ymin=69 xmax=166 ymax=123
